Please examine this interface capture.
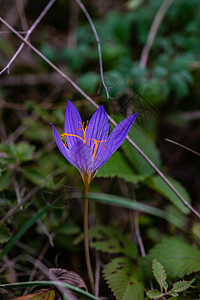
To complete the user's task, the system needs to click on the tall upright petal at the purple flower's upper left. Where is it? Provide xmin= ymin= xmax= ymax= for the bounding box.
xmin=65 ymin=100 xmax=83 ymax=148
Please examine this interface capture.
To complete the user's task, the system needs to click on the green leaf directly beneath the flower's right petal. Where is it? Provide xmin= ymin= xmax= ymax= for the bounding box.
xmin=96 ymin=151 xmax=146 ymax=183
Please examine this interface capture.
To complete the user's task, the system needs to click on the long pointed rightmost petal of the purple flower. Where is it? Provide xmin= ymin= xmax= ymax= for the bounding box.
xmin=94 ymin=113 xmax=138 ymax=171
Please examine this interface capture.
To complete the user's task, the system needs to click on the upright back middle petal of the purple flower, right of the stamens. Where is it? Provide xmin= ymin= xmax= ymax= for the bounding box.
xmin=86 ymin=105 xmax=109 ymax=147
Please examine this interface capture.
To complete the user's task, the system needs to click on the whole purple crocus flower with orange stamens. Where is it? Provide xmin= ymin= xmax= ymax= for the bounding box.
xmin=51 ymin=100 xmax=137 ymax=186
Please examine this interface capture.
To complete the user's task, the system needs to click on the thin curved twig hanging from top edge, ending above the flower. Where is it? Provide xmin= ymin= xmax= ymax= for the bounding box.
xmin=76 ymin=0 xmax=110 ymax=99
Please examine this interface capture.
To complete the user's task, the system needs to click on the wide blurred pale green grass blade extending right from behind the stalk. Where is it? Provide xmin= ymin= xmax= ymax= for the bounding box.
xmin=88 ymin=193 xmax=182 ymax=228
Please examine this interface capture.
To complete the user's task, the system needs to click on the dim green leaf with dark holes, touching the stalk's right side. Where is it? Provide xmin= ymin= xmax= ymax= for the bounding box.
xmin=89 ymin=226 xmax=137 ymax=259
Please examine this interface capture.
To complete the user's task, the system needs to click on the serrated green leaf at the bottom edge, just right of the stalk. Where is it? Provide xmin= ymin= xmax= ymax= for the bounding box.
xmin=103 ymin=257 xmax=144 ymax=300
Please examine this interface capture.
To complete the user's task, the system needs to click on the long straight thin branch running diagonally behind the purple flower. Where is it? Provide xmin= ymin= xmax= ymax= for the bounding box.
xmin=0 ymin=17 xmax=200 ymax=218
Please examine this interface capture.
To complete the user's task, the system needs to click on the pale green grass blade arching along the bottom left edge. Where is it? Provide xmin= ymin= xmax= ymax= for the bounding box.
xmin=0 ymin=281 xmax=99 ymax=300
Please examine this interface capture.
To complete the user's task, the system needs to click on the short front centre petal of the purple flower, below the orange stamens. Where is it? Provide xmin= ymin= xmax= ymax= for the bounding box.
xmin=69 ymin=141 xmax=93 ymax=175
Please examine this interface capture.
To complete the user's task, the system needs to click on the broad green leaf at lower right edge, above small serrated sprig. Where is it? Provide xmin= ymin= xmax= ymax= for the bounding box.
xmin=144 ymin=238 xmax=200 ymax=278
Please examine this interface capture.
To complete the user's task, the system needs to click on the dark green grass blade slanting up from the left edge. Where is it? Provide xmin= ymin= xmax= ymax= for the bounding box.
xmin=0 ymin=205 xmax=52 ymax=259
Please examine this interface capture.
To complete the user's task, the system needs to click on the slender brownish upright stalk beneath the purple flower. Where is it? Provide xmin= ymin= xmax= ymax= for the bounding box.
xmin=83 ymin=184 xmax=95 ymax=294
